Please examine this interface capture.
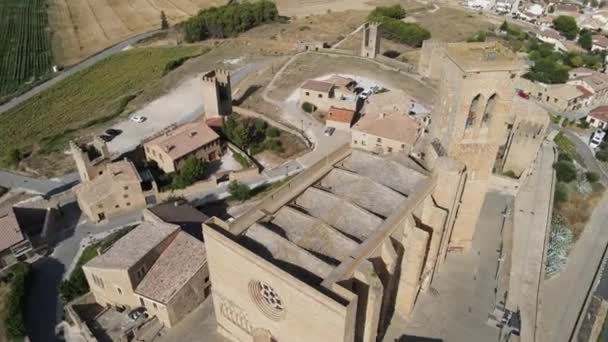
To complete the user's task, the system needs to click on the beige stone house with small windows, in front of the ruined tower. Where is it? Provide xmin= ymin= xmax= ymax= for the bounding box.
xmin=74 ymin=159 xmax=157 ymax=222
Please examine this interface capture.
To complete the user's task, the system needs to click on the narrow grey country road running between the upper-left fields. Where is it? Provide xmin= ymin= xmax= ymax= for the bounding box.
xmin=0 ymin=30 xmax=160 ymax=114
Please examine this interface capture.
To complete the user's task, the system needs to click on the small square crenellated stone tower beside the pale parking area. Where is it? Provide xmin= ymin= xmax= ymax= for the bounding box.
xmin=203 ymin=69 xmax=232 ymax=120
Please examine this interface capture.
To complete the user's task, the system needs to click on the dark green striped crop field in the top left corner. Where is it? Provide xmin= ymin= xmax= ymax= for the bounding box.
xmin=0 ymin=0 xmax=53 ymax=101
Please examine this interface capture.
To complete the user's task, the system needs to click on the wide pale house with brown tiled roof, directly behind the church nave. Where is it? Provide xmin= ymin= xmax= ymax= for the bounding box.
xmin=351 ymin=112 xmax=422 ymax=154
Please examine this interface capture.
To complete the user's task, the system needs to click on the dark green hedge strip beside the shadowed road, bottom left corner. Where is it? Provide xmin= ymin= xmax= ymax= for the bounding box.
xmin=3 ymin=262 xmax=31 ymax=340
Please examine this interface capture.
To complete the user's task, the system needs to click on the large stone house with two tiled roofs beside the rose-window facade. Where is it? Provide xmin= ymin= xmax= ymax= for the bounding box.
xmin=82 ymin=222 xmax=211 ymax=327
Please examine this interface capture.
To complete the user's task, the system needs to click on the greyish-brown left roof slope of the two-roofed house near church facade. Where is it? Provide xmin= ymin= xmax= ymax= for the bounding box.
xmin=85 ymin=222 xmax=179 ymax=270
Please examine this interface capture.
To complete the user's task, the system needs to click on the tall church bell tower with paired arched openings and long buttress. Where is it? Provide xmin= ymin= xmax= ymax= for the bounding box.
xmin=429 ymin=43 xmax=524 ymax=250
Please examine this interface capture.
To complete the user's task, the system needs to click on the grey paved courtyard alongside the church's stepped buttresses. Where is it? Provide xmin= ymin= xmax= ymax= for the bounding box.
xmin=384 ymin=192 xmax=513 ymax=342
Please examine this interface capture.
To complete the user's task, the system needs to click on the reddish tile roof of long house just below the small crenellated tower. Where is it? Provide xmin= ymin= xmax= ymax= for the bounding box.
xmin=145 ymin=122 xmax=220 ymax=160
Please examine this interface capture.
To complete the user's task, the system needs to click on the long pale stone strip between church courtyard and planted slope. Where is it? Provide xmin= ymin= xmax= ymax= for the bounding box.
xmin=507 ymin=141 xmax=556 ymax=341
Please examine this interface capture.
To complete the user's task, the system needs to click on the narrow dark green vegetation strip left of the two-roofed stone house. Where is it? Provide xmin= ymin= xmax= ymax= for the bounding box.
xmin=60 ymin=225 xmax=137 ymax=303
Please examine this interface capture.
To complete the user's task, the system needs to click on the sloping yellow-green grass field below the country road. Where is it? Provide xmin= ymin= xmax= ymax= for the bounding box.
xmin=0 ymin=46 xmax=203 ymax=166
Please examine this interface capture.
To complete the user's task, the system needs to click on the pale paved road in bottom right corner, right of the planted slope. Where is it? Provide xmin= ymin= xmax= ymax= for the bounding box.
xmin=538 ymin=193 xmax=608 ymax=341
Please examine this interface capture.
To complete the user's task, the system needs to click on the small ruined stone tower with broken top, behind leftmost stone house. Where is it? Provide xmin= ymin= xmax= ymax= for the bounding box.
xmin=70 ymin=137 xmax=110 ymax=182
